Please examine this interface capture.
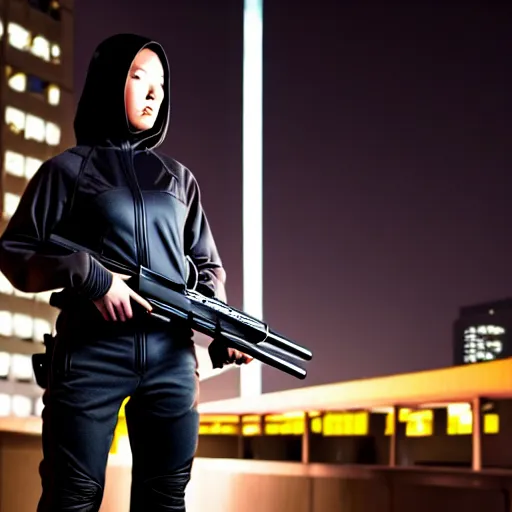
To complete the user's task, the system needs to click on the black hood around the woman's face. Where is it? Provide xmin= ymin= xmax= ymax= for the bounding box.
xmin=74 ymin=34 xmax=170 ymax=149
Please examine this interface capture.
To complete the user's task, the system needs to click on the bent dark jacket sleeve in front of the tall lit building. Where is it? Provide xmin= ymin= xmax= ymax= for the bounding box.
xmin=0 ymin=159 xmax=112 ymax=300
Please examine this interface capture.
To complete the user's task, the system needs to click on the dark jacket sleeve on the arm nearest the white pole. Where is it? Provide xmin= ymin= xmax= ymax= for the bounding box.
xmin=185 ymin=178 xmax=226 ymax=302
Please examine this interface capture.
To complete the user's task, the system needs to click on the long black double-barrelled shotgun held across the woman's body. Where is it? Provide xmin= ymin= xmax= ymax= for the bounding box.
xmin=49 ymin=235 xmax=313 ymax=379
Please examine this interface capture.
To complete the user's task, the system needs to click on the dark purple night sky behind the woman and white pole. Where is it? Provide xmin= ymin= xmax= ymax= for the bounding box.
xmin=76 ymin=0 xmax=512 ymax=397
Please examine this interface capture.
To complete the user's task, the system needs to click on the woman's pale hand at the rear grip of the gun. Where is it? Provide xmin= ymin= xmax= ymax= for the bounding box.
xmin=93 ymin=272 xmax=153 ymax=322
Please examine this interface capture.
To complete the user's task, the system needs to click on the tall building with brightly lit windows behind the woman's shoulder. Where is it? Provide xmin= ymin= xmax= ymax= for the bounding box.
xmin=0 ymin=0 xmax=74 ymax=416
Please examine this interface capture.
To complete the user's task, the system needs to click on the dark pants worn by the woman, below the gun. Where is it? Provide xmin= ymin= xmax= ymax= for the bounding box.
xmin=37 ymin=316 xmax=199 ymax=512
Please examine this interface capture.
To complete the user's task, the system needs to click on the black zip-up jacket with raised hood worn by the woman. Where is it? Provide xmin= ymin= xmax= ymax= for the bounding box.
xmin=0 ymin=34 xmax=225 ymax=312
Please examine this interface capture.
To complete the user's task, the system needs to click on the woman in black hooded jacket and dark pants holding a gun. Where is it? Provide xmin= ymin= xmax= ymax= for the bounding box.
xmin=0 ymin=34 xmax=249 ymax=512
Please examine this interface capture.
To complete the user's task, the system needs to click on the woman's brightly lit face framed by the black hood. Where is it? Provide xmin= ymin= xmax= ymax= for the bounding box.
xmin=124 ymin=48 xmax=164 ymax=130
